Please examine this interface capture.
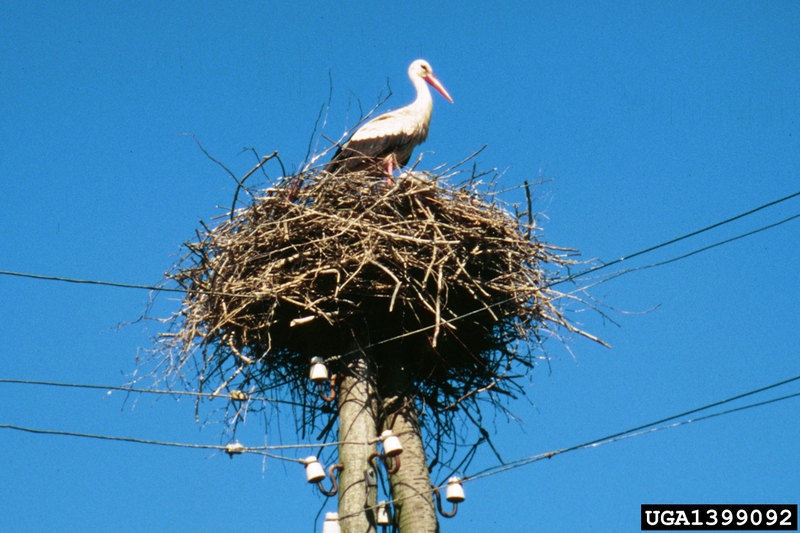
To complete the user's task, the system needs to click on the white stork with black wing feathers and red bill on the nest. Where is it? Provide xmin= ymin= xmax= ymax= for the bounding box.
xmin=325 ymin=59 xmax=453 ymax=176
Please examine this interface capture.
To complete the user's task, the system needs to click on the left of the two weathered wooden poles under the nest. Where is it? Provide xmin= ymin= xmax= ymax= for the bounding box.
xmin=338 ymin=343 xmax=378 ymax=533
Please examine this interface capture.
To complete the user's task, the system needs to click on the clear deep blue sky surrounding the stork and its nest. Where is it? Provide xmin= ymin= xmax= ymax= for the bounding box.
xmin=0 ymin=1 xmax=800 ymax=532
